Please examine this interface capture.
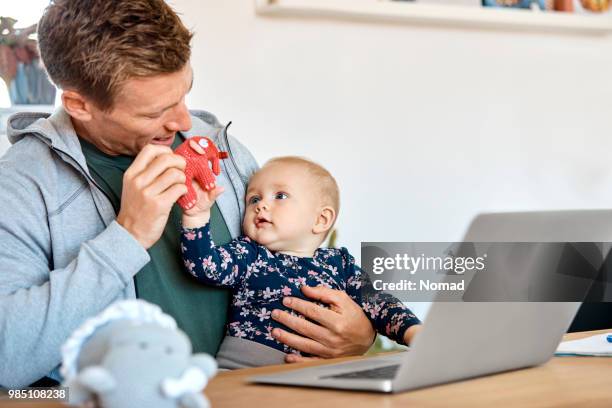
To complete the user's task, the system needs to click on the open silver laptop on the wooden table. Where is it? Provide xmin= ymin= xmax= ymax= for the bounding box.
xmin=249 ymin=210 xmax=612 ymax=393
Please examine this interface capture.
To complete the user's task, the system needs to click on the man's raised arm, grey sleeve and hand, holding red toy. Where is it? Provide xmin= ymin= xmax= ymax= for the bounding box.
xmin=0 ymin=145 xmax=187 ymax=387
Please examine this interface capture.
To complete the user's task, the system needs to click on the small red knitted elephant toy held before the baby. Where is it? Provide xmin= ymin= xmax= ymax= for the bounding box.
xmin=174 ymin=136 xmax=229 ymax=210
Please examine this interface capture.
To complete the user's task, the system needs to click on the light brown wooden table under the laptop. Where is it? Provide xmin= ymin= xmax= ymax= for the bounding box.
xmin=0 ymin=330 xmax=612 ymax=408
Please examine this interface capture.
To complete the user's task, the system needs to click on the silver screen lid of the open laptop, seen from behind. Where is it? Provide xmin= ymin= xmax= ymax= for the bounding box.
xmin=392 ymin=210 xmax=612 ymax=391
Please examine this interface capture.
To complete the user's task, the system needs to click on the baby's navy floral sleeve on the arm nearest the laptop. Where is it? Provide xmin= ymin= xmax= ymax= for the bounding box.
xmin=340 ymin=248 xmax=421 ymax=344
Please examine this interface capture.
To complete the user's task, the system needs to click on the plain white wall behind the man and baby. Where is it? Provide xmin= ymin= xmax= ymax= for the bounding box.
xmin=171 ymin=0 xmax=612 ymax=254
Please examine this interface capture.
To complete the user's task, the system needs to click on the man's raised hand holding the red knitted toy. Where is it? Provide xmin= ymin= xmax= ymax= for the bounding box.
xmin=117 ymin=144 xmax=187 ymax=249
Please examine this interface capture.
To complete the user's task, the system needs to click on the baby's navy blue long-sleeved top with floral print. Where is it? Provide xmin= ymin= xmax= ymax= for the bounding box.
xmin=181 ymin=224 xmax=420 ymax=353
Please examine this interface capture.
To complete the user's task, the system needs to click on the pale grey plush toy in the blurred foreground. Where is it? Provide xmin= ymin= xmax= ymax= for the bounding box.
xmin=60 ymin=300 xmax=217 ymax=408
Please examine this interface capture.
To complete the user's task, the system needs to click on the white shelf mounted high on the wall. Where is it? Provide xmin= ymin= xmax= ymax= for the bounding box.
xmin=255 ymin=0 xmax=612 ymax=35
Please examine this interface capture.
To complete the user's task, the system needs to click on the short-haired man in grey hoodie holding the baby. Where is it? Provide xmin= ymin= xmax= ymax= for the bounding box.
xmin=0 ymin=0 xmax=374 ymax=387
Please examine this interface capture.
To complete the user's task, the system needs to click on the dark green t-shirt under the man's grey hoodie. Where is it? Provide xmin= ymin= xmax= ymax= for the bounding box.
xmin=79 ymin=135 xmax=231 ymax=355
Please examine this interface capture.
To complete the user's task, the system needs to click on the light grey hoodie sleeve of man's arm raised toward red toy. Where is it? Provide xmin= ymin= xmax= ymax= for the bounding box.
xmin=0 ymin=169 xmax=149 ymax=387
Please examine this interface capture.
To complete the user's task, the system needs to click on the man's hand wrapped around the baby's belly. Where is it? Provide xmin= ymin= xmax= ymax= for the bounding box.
xmin=272 ymin=286 xmax=376 ymax=363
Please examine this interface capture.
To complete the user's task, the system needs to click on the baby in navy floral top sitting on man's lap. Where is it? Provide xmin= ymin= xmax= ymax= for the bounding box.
xmin=181 ymin=153 xmax=420 ymax=368
